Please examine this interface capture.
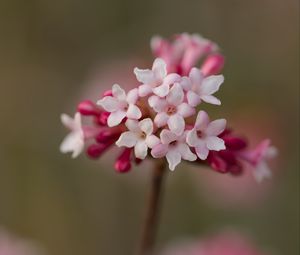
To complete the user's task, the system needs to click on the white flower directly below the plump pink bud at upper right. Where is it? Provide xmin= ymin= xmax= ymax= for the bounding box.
xmin=181 ymin=67 xmax=224 ymax=107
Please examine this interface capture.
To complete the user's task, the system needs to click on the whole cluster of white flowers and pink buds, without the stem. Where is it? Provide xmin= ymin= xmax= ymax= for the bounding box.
xmin=61 ymin=34 xmax=272 ymax=180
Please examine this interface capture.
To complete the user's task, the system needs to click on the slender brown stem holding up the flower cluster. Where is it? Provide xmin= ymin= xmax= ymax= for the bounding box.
xmin=138 ymin=160 xmax=166 ymax=255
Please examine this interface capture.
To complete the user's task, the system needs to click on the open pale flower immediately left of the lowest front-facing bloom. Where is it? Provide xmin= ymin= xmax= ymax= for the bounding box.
xmin=116 ymin=118 xmax=159 ymax=159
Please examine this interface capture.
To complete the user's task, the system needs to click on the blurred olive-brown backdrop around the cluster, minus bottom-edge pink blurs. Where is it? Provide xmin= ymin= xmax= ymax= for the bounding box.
xmin=0 ymin=0 xmax=299 ymax=255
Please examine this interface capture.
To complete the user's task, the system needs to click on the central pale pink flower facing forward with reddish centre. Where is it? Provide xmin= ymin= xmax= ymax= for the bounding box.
xmin=148 ymin=83 xmax=195 ymax=135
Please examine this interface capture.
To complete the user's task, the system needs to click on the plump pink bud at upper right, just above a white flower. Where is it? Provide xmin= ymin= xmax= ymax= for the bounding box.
xmin=200 ymin=54 xmax=225 ymax=76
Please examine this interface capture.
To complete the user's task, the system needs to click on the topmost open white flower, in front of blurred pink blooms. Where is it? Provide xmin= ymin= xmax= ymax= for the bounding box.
xmin=134 ymin=58 xmax=180 ymax=97
